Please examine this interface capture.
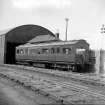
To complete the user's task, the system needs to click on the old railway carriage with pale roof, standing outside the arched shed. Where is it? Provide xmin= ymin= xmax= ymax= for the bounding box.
xmin=16 ymin=40 xmax=92 ymax=71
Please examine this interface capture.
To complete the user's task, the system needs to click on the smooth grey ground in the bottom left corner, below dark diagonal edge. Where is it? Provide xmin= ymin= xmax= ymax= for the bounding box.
xmin=0 ymin=79 xmax=54 ymax=105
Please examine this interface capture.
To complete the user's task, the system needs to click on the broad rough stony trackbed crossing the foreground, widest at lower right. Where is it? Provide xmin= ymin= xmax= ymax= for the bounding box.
xmin=0 ymin=64 xmax=105 ymax=105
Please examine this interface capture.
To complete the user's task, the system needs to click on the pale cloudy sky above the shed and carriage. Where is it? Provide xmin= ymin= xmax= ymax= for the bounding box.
xmin=0 ymin=0 xmax=105 ymax=49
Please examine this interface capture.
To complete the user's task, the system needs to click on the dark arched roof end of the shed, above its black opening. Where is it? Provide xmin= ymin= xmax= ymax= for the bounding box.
xmin=0 ymin=25 xmax=55 ymax=43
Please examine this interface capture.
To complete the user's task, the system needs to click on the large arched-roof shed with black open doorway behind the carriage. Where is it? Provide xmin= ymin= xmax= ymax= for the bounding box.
xmin=0 ymin=24 xmax=55 ymax=64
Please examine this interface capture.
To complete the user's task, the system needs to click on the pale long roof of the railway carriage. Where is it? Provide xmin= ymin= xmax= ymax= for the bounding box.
xmin=18 ymin=40 xmax=88 ymax=47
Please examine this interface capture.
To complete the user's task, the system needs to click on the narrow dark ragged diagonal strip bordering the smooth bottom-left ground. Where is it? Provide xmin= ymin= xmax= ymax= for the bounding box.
xmin=0 ymin=73 xmax=71 ymax=105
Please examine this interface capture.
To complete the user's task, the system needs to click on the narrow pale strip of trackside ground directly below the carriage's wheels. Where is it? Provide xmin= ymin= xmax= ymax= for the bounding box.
xmin=1 ymin=65 xmax=105 ymax=87
